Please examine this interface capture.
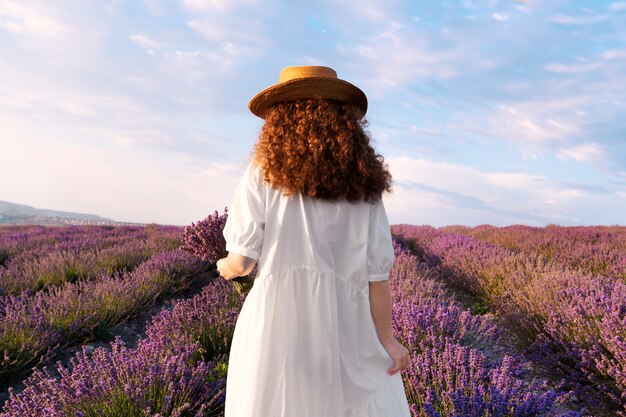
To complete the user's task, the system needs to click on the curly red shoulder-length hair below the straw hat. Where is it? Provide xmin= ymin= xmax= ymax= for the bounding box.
xmin=253 ymin=99 xmax=391 ymax=202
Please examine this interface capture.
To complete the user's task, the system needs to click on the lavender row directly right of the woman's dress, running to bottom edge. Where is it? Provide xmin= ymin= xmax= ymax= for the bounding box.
xmin=390 ymin=246 xmax=583 ymax=417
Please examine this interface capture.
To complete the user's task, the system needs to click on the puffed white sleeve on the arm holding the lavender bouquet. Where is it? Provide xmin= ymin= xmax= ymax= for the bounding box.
xmin=223 ymin=163 xmax=266 ymax=260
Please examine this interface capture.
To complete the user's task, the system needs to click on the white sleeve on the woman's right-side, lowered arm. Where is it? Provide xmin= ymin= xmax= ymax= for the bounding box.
xmin=367 ymin=199 xmax=394 ymax=281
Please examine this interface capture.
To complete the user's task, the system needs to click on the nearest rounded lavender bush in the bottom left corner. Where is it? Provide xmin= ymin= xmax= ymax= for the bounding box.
xmin=0 ymin=338 xmax=225 ymax=417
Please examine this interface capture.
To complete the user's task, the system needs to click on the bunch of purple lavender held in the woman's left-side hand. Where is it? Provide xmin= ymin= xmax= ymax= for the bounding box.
xmin=181 ymin=208 xmax=256 ymax=295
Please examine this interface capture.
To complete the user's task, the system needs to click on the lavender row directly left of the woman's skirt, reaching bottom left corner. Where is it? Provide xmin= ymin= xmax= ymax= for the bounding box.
xmin=0 ymin=270 xmax=240 ymax=417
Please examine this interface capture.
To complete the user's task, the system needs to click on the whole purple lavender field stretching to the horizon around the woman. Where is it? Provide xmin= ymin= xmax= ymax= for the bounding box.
xmin=0 ymin=219 xmax=626 ymax=417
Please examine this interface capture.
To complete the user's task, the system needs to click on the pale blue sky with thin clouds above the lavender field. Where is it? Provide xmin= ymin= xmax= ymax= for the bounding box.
xmin=0 ymin=0 xmax=626 ymax=227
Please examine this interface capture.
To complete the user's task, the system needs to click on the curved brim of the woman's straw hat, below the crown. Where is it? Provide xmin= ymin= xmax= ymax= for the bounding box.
xmin=248 ymin=77 xmax=367 ymax=119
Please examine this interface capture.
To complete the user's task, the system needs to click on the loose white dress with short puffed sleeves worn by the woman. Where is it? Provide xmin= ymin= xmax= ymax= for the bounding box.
xmin=224 ymin=164 xmax=411 ymax=417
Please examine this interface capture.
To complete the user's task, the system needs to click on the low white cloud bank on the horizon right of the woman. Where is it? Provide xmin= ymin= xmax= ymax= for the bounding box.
xmin=385 ymin=157 xmax=599 ymax=226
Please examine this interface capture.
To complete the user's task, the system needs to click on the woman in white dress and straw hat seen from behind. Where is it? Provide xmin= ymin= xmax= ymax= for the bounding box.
xmin=217 ymin=66 xmax=410 ymax=417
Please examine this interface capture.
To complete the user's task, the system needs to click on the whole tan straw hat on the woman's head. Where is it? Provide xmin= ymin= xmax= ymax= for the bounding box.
xmin=248 ymin=66 xmax=367 ymax=119
